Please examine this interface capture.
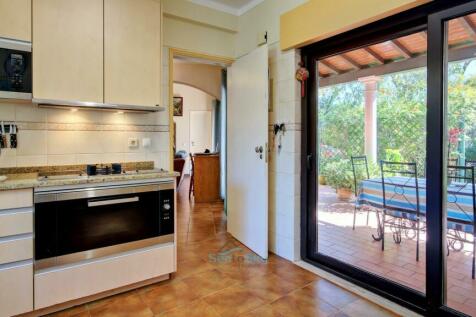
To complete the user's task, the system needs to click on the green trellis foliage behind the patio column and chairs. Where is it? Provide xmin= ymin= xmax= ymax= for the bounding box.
xmin=318 ymin=59 xmax=476 ymax=176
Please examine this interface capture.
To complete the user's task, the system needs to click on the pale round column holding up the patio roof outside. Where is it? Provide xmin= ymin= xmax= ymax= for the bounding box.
xmin=359 ymin=76 xmax=380 ymax=163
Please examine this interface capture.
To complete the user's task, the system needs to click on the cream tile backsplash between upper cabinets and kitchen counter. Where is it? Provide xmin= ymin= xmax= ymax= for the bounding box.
xmin=0 ymin=103 xmax=169 ymax=169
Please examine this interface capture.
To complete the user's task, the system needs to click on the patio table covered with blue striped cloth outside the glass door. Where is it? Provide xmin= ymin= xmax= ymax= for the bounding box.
xmin=356 ymin=176 xmax=474 ymax=233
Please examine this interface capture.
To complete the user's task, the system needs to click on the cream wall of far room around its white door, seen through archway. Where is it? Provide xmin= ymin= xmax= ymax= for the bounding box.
xmin=174 ymin=84 xmax=215 ymax=173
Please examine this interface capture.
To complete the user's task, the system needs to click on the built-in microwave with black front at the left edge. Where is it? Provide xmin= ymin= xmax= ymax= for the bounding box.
xmin=0 ymin=38 xmax=32 ymax=99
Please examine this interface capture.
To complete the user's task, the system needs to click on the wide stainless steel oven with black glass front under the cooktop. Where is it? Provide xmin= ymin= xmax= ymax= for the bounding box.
xmin=34 ymin=182 xmax=174 ymax=270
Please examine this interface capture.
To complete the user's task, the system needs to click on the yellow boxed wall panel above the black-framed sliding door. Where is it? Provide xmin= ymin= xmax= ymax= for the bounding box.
xmin=281 ymin=0 xmax=431 ymax=50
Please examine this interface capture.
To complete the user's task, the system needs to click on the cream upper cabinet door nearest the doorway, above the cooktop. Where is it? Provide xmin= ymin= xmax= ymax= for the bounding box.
xmin=104 ymin=0 xmax=161 ymax=106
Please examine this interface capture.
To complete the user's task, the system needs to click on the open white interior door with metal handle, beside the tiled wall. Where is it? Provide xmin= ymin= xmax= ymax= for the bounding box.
xmin=227 ymin=45 xmax=268 ymax=259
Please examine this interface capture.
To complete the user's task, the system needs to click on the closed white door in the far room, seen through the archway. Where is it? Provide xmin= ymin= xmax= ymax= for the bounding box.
xmin=190 ymin=111 xmax=212 ymax=153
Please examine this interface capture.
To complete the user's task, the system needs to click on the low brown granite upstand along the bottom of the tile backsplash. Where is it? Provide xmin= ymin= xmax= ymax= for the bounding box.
xmin=0 ymin=161 xmax=154 ymax=175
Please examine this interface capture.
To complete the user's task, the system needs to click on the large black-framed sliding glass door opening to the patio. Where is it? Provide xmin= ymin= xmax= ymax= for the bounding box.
xmin=302 ymin=1 xmax=476 ymax=315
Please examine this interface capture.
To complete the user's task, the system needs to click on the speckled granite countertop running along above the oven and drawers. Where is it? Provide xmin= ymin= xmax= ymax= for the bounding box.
xmin=0 ymin=170 xmax=179 ymax=191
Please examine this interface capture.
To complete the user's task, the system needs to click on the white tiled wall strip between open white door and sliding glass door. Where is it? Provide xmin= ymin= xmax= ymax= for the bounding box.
xmin=268 ymin=43 xmax=301 ymax=261
